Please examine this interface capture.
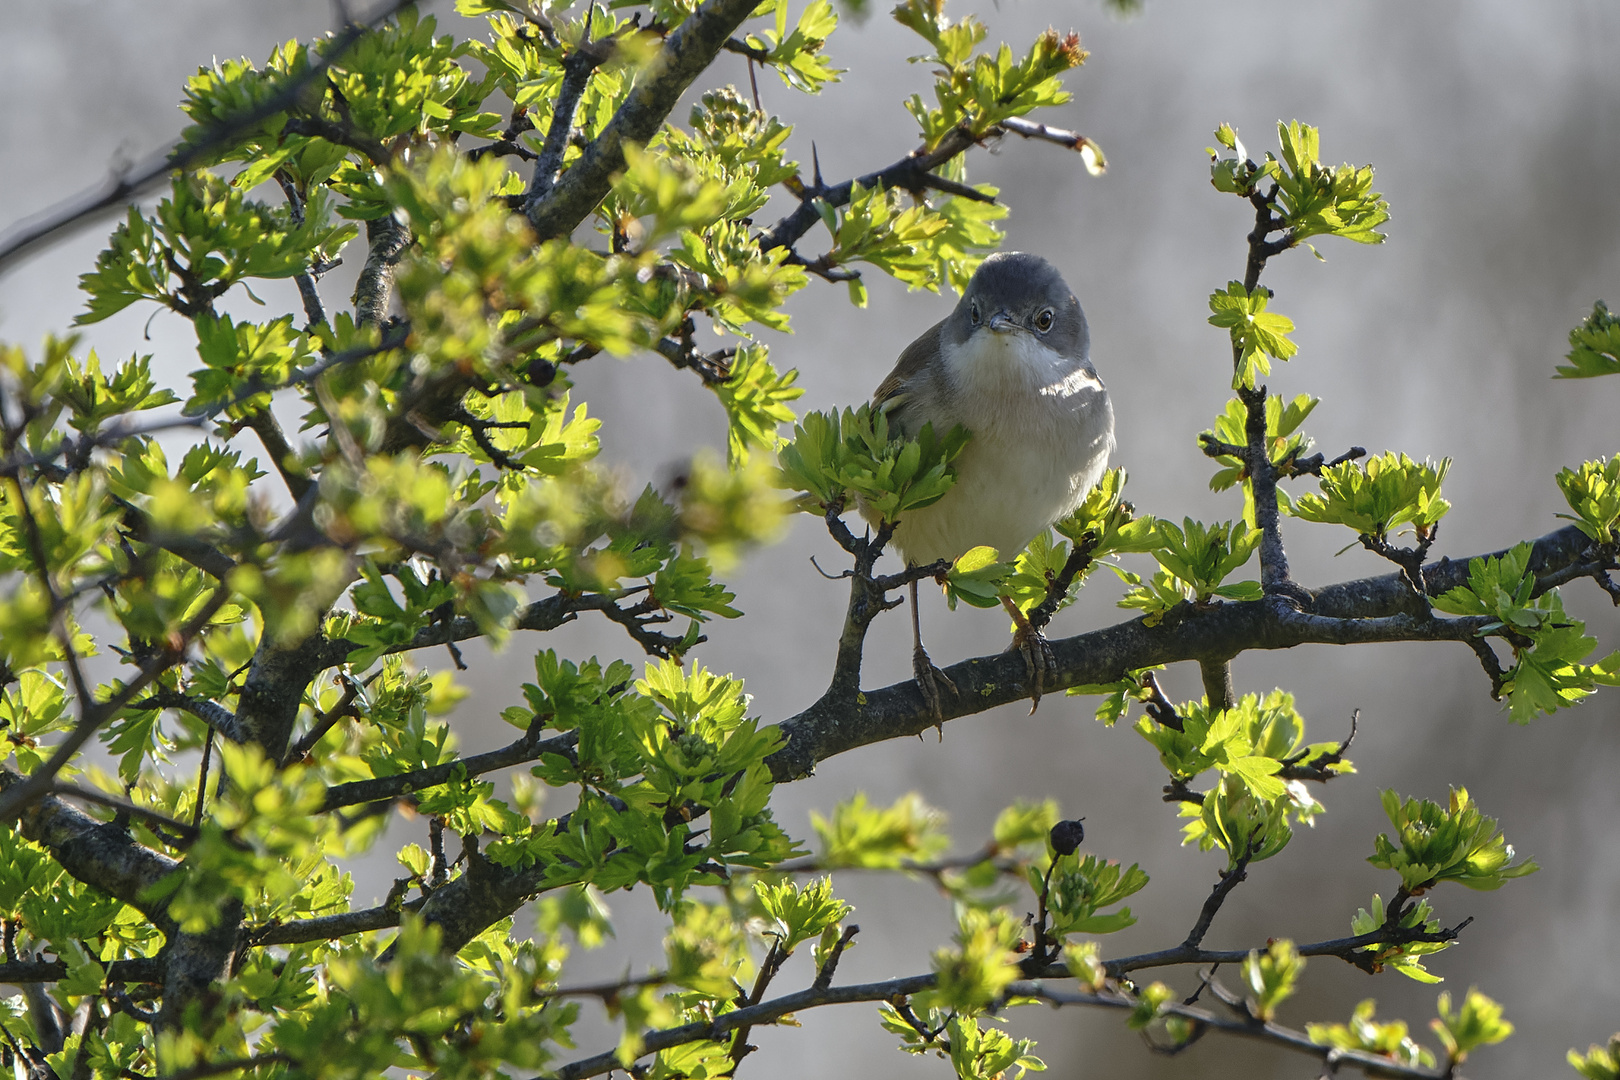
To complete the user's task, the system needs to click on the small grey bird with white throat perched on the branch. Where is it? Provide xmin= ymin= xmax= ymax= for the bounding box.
xmin=872 ymin=251 xmax=1115 ymax=717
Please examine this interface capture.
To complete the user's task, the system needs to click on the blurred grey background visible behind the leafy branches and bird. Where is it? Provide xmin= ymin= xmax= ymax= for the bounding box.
xmin=0 ymin=0 xmax=1620 ymax=1080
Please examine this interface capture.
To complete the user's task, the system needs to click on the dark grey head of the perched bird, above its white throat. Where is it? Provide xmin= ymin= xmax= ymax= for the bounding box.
xmin=944 ymin=251 xmax=1092 ymax=359
